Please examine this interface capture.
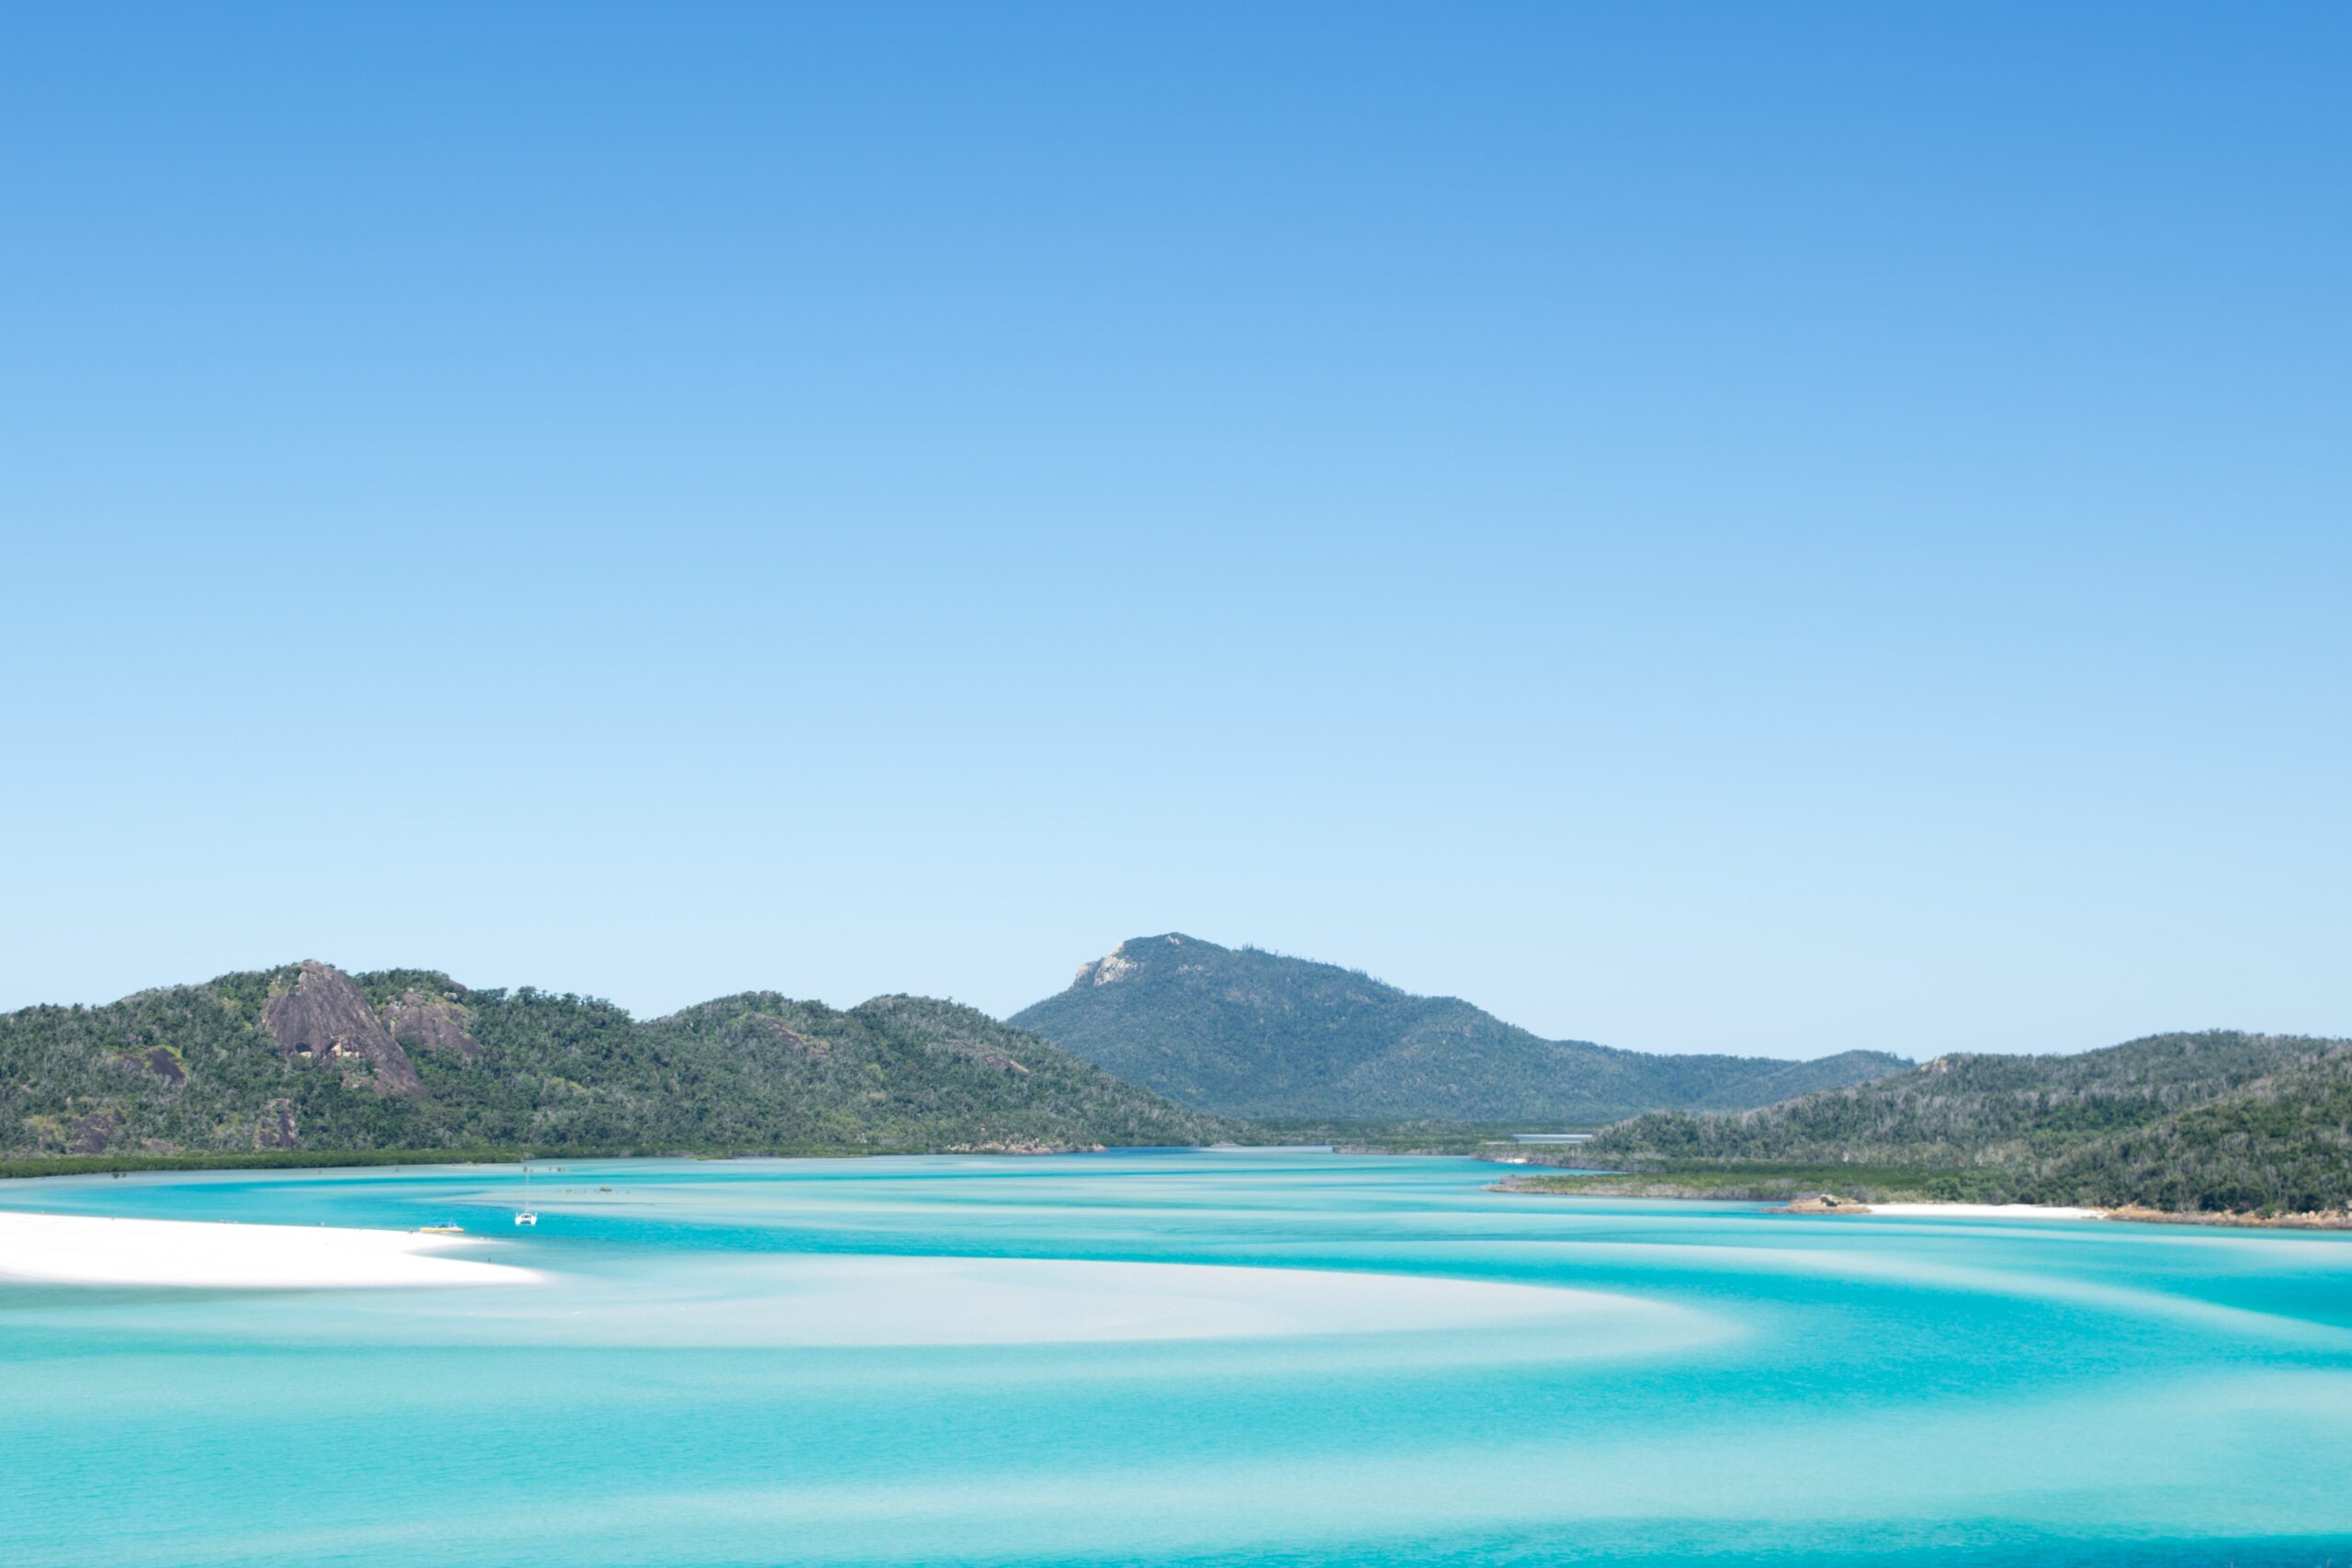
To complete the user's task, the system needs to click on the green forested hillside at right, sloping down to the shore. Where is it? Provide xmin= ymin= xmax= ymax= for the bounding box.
xmin=1578 ymin=1030 xmax=2352 ymax=1213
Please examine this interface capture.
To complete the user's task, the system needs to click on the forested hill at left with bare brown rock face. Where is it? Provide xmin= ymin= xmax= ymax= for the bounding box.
xmin=0 ymin=964 xmax=1221 ymax=1155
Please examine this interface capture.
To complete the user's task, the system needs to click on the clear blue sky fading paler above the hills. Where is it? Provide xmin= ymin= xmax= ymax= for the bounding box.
xmin=0 ymin=5 xmax=2352 ymax=1055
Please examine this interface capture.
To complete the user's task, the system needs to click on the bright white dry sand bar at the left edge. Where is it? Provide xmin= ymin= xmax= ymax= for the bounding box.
xmin=0 ymin=1211 xmax=538 ymax=1288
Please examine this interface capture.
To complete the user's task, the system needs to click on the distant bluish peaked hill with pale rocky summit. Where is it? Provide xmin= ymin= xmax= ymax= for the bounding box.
xmin=1012 ymin=933 xmax=1910 ymax=1123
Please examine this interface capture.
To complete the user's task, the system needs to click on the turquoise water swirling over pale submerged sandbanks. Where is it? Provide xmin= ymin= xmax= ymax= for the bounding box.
xmin=0 ymin=1152 xmax=2352 ymax=1568
